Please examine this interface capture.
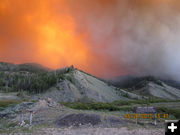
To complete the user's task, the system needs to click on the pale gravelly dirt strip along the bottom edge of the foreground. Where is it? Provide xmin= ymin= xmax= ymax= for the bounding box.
xmin=34 ymin=127 xmax=164 ymax=135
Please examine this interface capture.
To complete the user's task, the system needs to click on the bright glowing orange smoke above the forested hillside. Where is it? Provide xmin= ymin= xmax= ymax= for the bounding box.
xmin=0 ymin=0 xmax=93 ymax=73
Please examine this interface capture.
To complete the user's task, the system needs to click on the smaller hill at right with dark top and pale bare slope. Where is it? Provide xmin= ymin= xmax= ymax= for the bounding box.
xmin=112 ymin=76 xmax=180 ymax=100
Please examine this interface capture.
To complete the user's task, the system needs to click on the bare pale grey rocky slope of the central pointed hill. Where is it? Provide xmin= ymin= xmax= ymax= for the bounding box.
xmin=32 ymin=69 xmax=142 ymax=102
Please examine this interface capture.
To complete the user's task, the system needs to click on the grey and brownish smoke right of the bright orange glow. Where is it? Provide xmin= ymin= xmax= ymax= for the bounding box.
xmin=67 ymin=0 xmax=180 ymax=80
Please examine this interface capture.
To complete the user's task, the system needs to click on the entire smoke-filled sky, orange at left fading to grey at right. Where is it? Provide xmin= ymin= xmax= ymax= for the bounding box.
xmin=0 ymin=0 xmax=180 ymax=80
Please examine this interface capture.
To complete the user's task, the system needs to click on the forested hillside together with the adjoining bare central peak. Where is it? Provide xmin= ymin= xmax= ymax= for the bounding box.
xmin=0 ymin=63 xmax=142 ymax=102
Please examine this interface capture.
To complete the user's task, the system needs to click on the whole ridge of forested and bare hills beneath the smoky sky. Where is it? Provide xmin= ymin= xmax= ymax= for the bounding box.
xmin=0 ymin=63 xmax=180 ymax=102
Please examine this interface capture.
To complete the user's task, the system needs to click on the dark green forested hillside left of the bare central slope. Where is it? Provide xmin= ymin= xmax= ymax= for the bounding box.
xmin=0 ymin=63 xmax=72 ymax=93
